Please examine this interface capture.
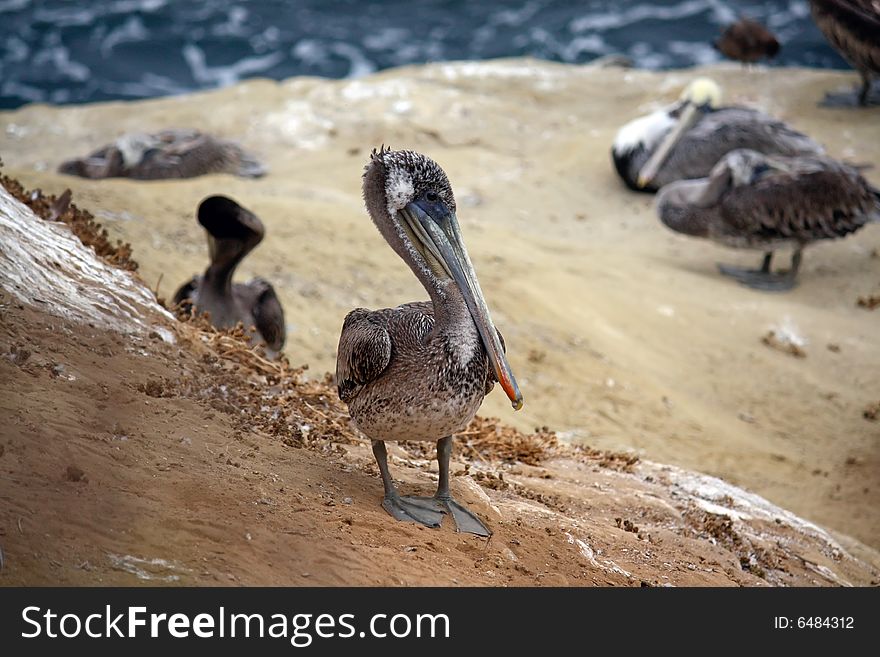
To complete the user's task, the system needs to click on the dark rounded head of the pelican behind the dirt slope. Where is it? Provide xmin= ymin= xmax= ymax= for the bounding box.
xmin=197 ymin=196 xmax=266 ymax=266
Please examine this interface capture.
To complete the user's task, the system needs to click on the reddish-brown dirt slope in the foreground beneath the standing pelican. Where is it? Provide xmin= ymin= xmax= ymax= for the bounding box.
xmin=0 ymin=181 xmax=880 ymax=586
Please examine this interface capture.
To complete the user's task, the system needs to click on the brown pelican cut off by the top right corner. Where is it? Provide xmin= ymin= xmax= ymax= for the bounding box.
xmin=810 ymin=0 xmax=880 ymax=105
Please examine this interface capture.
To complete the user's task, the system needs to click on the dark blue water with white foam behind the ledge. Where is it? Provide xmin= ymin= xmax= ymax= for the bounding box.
xmin=0 ymin=0 xmax=847 ymax=108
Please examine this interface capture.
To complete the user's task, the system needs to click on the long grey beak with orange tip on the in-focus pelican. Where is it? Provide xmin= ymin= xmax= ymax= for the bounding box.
xmin=400 ymin=200 xmax=523 ymax=411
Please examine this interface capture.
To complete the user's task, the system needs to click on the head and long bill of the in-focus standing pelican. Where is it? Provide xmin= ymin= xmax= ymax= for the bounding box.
xmin=364 ymin=147 xmax=522 ymax=410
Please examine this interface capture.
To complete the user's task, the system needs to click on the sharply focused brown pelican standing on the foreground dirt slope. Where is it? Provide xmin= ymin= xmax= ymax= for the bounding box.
xmin=336 ymin=147 xmax=522 ymax=536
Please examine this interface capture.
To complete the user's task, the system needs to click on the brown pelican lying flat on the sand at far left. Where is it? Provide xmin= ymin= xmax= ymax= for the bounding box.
xmin=58 ymin=130 xmax=266 ymax=180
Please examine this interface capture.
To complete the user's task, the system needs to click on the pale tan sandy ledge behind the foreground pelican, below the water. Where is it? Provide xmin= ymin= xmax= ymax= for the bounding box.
xmin=0 ymin=60 xmax=880 ymax=560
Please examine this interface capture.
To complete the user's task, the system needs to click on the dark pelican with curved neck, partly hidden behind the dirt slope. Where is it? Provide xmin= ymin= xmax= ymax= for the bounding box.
xmin=174 ymin=196 xmax=285 ymax=356
